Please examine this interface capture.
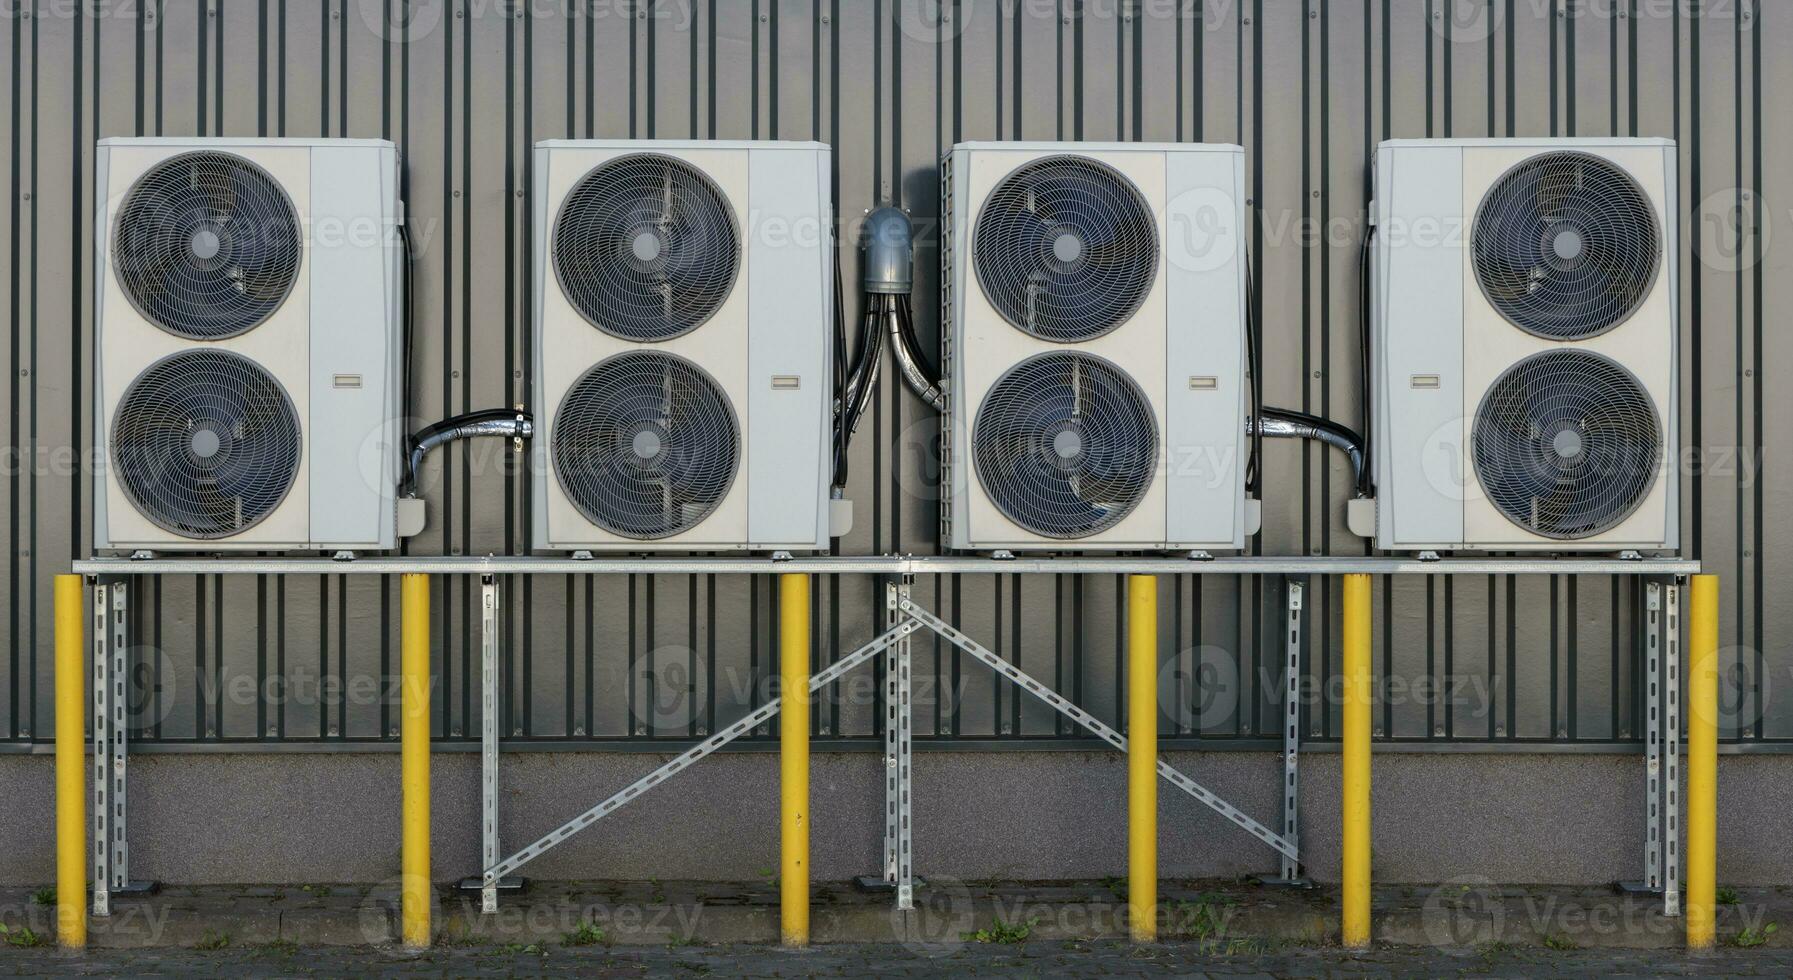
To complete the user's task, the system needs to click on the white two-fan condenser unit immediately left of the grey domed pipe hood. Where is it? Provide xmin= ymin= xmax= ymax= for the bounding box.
xmin=533 ymin=140 xmax=834 ymax=552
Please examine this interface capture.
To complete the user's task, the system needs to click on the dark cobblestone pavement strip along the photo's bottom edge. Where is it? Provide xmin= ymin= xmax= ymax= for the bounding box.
xmin=10 ymin=941 xmax=1793 ymax=978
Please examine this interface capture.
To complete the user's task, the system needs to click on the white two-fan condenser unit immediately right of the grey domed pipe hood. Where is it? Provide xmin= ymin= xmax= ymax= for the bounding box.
xmin=941 ymin=142 xmax=1255 ymax=552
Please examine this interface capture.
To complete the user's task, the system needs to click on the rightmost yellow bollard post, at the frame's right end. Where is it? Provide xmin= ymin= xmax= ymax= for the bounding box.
xmin=1685 ymin=575 xmax=1718 ymax=950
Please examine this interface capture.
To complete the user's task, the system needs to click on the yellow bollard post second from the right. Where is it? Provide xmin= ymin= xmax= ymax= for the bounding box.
xmin=1339 ymin=575 xmax=1372 ymax=948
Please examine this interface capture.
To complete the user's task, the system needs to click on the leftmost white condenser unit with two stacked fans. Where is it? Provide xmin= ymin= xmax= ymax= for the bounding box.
xmin=93 ymin=138 xmax=403 ymax=552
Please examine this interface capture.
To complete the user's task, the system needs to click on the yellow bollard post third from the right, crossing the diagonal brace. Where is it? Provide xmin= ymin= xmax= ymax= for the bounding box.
xmin=1126 ymin=575 xmax=1158 ymax=942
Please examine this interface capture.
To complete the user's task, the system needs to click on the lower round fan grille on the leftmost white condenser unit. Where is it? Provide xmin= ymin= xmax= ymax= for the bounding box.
xmin=111 ymin=349 xmax=301 ymax=539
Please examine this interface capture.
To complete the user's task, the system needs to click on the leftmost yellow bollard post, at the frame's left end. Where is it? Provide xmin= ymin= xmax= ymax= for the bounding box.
xmin=56 ymin=575 xmax=88 ymax=950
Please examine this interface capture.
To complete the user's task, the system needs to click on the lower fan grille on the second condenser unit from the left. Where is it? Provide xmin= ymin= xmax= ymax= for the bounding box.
xmin=554 ymin=351 xmax=741 ymax=539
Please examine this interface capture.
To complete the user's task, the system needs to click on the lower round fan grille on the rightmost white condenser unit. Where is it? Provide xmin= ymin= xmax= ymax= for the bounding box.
xmin=1472 ymin=349 xmax=1662 ymax=539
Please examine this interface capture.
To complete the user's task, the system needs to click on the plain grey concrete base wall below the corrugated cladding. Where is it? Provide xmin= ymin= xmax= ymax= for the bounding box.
xmin=0 ymin=752 xmax=1793 ymax=885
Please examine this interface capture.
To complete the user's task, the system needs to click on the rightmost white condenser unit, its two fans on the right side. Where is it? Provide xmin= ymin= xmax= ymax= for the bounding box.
xmin=1370 ymin=138 xmax=1680 ymax=552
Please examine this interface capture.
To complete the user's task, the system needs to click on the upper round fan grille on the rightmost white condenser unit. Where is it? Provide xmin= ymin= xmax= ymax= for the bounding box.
xmin=1472 ymin=152 xmax=1662 ymax=340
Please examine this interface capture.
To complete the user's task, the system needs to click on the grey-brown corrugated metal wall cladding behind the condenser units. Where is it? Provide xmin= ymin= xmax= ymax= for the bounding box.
xmin=0 ymin=0 xmax=1793 ymax=752
